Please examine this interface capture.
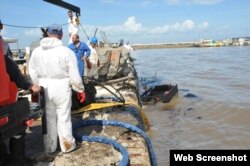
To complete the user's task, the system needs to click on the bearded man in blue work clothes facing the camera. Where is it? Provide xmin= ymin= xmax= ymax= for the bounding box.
xmin=68 ymin=34 xmax=91 ymax=77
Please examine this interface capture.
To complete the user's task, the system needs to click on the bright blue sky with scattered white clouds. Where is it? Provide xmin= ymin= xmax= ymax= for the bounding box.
xmin=0 ymin=0 xmax=250 ymax=48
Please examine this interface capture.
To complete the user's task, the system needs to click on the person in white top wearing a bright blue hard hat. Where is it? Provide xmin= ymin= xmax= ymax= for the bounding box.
xmin=87 ymin=37 xmax=99 ymax=79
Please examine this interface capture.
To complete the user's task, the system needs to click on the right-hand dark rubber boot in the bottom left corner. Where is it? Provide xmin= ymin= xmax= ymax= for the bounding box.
xmin=10 ymin=134 xmax=34 ymax=166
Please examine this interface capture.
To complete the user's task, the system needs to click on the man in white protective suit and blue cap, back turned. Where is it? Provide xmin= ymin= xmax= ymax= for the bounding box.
xmin=29 ymin=24 xmax=85 ymax=157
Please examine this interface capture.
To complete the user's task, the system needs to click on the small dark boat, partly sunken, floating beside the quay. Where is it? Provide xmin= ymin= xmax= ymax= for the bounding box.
xmin=141 ymin=84 xmax=178 ymax=103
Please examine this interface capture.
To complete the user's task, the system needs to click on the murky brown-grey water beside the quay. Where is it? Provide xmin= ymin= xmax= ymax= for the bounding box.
xmin=132 ymin=47 xmax=250 ymax=166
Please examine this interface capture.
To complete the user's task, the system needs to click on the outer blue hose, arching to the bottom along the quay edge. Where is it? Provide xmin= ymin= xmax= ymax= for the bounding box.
xmin=73 ymin=120 xmax=157 ymax=166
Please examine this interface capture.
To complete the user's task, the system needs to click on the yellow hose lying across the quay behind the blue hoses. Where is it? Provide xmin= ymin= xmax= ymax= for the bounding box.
xmin=71 ymin=102 xmax=151 ymax=131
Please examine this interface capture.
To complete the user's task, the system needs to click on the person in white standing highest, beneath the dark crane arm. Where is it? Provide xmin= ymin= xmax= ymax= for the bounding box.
xmin=68 ymin=10 xmax=79 ymax=43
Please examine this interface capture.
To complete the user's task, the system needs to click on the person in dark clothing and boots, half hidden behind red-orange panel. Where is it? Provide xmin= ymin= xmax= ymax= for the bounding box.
xmin=0 ymin=20 xmax=41 ymax=166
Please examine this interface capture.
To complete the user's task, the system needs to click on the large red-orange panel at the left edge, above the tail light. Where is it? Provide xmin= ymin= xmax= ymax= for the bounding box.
xmin=0 ymin=39 xmax=17 ymax=106
